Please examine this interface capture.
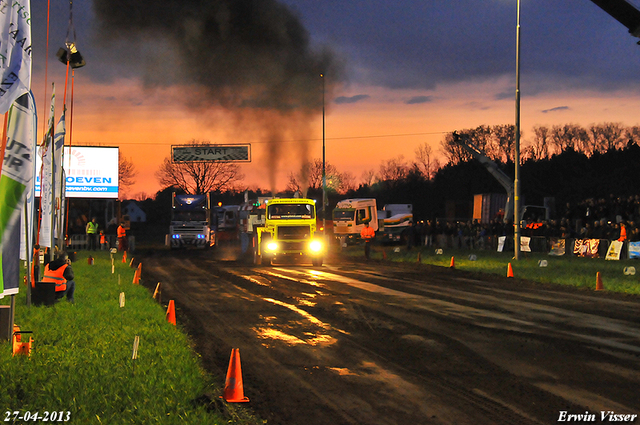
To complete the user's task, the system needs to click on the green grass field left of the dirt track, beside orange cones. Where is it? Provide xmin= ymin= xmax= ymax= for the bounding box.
xmin=0 ymin=252 xmax=257 ymax=425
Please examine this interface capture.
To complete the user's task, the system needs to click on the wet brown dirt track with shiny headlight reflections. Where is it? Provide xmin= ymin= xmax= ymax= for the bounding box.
xmin=142 ymin=251 xmax=640 ymax=425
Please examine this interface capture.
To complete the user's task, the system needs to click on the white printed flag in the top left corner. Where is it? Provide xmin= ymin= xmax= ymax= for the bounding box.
xmin=0 ymin=0 xmax=31 ymax=114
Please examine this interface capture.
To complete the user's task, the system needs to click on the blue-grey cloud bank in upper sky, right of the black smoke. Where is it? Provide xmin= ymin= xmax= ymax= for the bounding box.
xmin=283 ymin=0 xmax=640 ymax=93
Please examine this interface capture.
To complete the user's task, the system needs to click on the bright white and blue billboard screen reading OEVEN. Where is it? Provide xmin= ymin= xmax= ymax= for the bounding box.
xmin=36 ymin=146 xmax=118 ymax=199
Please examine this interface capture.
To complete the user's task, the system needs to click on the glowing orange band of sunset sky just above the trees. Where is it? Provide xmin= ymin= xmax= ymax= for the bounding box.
xmin=41 ymin=77 xmax=640 ymax=195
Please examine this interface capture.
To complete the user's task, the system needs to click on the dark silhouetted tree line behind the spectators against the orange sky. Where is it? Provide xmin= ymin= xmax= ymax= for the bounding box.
xmin=136 ymin=123 xmax=640 ymax=230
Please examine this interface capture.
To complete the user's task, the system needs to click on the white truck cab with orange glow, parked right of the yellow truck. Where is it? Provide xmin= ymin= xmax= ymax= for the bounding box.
xmin=333 ymin=198 xmax=378 ymax=246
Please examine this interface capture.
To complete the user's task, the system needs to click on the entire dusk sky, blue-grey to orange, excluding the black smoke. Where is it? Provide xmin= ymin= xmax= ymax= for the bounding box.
xmin=26 ymin=0 xmax=640 ymax=197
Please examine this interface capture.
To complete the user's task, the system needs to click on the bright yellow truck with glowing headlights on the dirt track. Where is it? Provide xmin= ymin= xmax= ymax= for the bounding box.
xmin=253 ymin=198 xmax=326 ymax=266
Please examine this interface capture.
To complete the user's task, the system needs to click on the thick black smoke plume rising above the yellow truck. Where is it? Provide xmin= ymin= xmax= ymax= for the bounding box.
xmin=93 ymin=0 xmax=343 ymax=192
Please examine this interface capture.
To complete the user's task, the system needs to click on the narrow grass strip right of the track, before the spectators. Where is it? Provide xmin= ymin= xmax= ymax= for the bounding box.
xmin=342 ymin=245 xmax=640 ymax=295
